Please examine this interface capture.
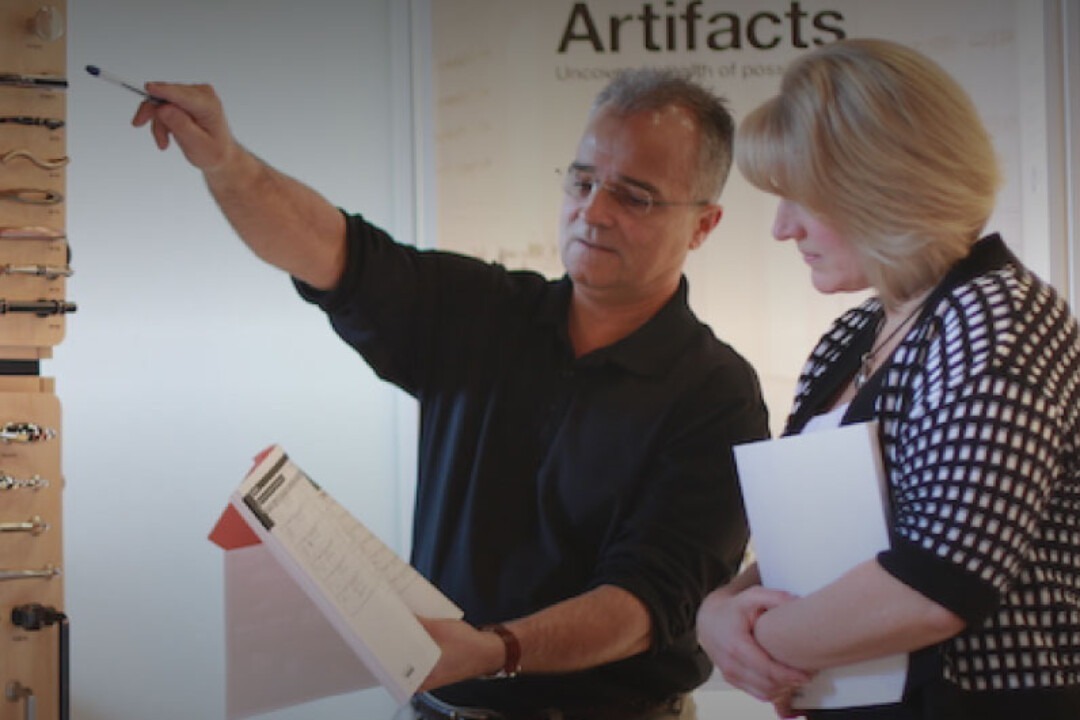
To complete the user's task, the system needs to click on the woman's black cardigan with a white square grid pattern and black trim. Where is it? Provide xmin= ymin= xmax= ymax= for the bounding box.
xmin=785 ymin=235 xmax=1080 ymax=699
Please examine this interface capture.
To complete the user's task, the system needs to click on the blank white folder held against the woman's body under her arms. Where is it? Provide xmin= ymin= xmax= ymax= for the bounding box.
xmin=734 ymin=422 xmax=907 ymax=708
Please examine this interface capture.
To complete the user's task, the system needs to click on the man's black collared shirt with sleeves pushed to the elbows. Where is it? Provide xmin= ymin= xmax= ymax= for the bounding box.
xmin=300 ymin=211 xmax=768 ymax=711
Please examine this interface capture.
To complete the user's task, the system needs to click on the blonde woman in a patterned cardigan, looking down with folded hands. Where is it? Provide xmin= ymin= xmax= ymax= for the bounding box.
xmin=698 ymin=40 xmax=1080 ymax=720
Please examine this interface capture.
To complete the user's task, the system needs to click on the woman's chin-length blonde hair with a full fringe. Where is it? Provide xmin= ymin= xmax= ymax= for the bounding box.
xmin=735 ymin=39 xmax=1001 ymax=303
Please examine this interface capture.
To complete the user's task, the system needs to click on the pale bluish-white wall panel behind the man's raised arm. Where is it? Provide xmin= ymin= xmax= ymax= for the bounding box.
xmin=60 ymin=0 xmax=410 ymax=720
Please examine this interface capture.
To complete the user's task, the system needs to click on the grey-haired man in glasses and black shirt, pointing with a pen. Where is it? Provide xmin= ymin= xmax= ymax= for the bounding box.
xmin=134 ymin=70 xmax=768 ymax=720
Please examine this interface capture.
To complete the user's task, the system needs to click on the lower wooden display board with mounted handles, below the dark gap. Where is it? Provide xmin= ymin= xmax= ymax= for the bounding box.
xmin=0 ymin=390 xmax=64 ymax=720
